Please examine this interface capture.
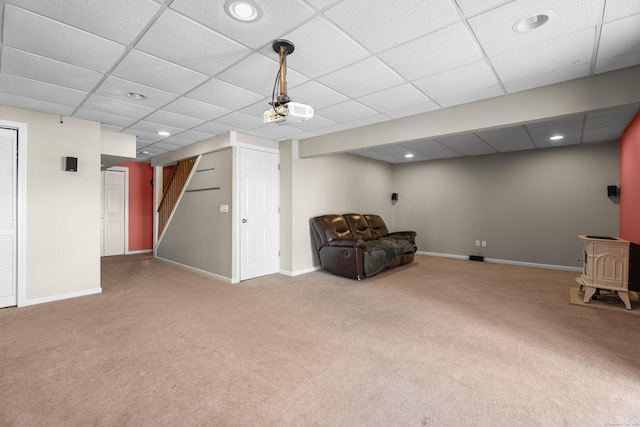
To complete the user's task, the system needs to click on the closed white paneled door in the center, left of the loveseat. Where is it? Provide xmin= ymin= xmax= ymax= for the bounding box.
xmin=240 ymin=148 xmax=280 ymax=280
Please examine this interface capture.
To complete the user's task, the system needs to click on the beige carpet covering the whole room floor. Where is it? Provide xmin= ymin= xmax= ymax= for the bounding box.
xmin=0 ymin=255 xmax=640 ymax=426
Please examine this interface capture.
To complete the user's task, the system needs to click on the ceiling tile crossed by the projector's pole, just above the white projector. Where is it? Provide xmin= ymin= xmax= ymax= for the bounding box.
xmin=217 ymin=52 xmax=309 ymax=98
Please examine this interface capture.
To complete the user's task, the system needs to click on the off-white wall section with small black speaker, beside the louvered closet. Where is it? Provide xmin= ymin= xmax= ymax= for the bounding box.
xmin=0 ymin=106 xmax=101 ymax=304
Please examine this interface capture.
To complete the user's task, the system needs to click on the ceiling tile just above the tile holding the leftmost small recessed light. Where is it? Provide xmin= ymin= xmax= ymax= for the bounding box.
xmin=112 ymin=49 xmax=208 ymax=95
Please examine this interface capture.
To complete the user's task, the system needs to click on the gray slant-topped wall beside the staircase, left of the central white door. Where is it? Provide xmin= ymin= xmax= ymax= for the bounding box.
xmin=157 ymin=148 xmax=233 ymax=280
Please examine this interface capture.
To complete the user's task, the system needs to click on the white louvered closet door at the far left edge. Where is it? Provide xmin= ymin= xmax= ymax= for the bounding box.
xmin=0 ymin=128 xmax=18 ymax=307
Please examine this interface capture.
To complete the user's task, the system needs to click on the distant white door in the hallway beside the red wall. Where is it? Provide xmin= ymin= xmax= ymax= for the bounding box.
xmin=103 ymin=169 xmax=125 ymax=256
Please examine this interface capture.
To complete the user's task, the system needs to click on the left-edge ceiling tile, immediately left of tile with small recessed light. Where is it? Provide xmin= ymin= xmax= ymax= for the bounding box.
xmin=0 ymin=46 xmax=103 ymax=92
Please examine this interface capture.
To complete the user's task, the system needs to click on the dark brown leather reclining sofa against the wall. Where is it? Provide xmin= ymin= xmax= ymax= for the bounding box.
xmin=311 ymin=213 xmax=416 ymax=280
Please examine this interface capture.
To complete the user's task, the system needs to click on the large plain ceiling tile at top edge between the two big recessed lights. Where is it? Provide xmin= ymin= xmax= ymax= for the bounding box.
xmin=325 ymin=0 xmax=459 ymax=52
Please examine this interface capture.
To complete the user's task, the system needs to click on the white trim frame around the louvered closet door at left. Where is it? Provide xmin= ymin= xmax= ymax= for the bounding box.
xmin=0 ymin=119 xmax=27 ymax=307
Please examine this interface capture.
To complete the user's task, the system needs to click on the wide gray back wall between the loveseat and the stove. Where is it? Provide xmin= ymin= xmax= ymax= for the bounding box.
xmin=392 ymin=141 xmax=619 ymax=267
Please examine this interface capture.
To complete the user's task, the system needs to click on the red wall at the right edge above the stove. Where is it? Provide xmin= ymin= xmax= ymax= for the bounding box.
xmin=620 ymin=113 xmax=640 ymax=243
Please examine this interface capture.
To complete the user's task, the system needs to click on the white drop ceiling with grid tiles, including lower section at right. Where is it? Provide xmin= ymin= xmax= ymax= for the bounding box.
xmin=0 ymin=0 xmax=640 ymax=163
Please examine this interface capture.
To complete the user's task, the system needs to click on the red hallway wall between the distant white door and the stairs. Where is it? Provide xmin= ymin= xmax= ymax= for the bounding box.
xmin=120 ymin=161 xmax=154 ymax=251
